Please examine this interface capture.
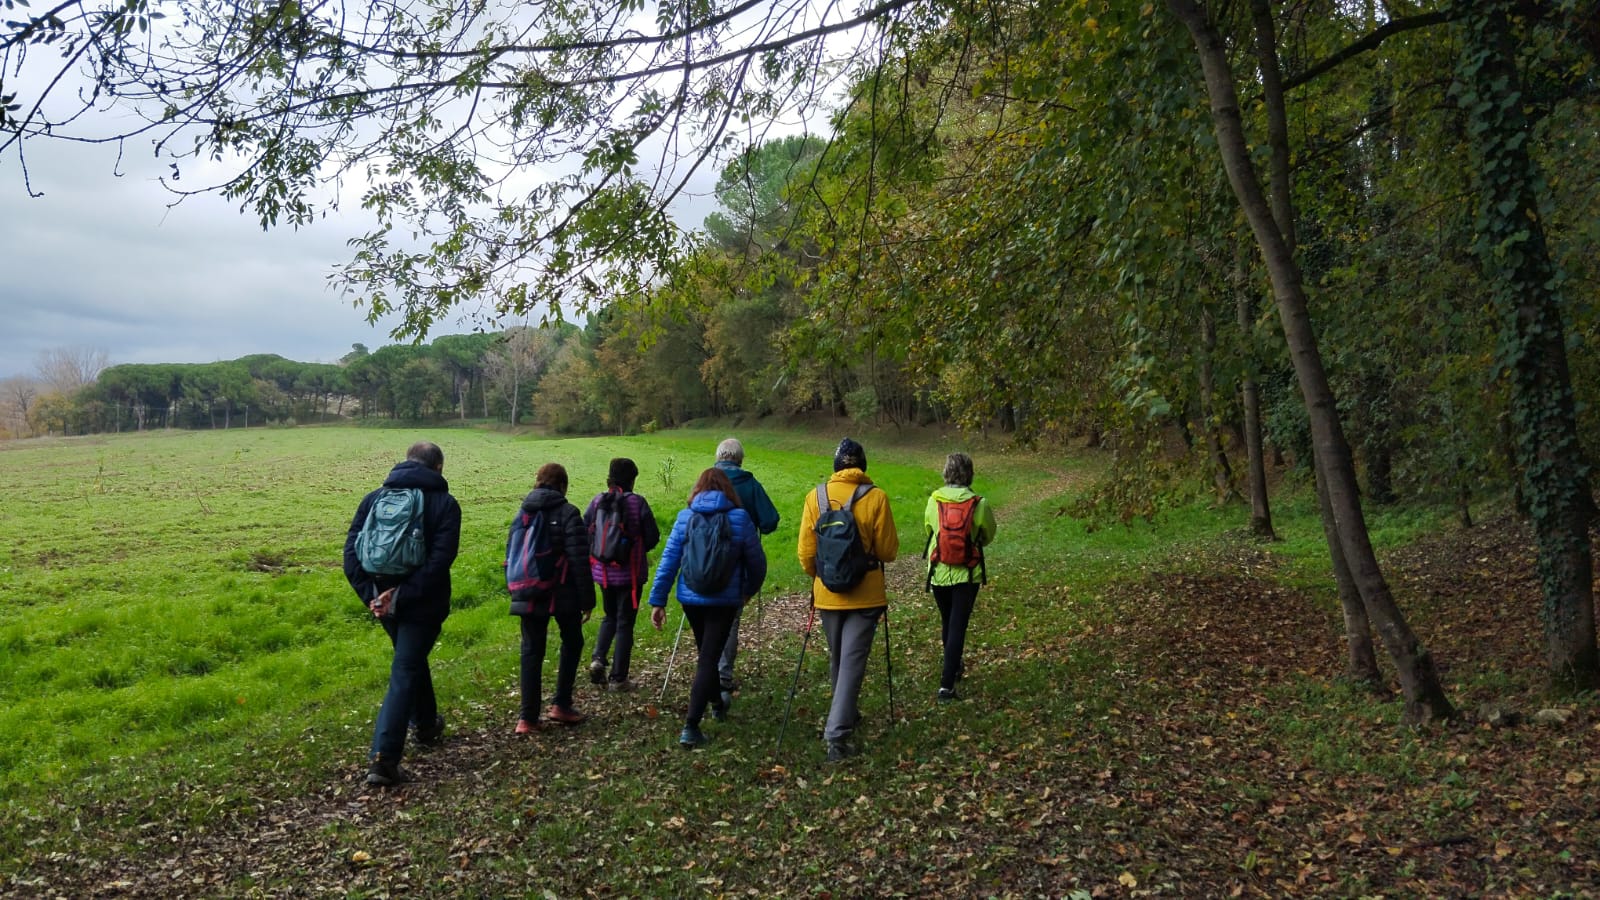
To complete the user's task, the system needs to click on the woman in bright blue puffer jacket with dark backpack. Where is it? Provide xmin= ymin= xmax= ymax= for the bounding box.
xmin=650 ymin=468 xmax=766 ymax=749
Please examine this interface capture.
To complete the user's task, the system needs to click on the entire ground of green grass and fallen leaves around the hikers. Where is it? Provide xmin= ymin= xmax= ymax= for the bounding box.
xmin=0 ymin=428 xmax=1600 ymax=897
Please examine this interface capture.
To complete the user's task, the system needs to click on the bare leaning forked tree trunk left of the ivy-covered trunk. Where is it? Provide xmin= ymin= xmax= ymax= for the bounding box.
xmin=1166 ymin=0 xmax=1454 ymax=722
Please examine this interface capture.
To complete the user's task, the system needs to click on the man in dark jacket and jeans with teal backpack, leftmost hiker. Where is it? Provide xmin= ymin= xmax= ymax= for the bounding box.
xmin=344 ymin=440 xmax=461 ymax=786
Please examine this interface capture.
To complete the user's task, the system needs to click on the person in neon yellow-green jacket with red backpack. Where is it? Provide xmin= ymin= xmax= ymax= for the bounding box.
xmin=923 ymin=453 xmax=995 ymax=701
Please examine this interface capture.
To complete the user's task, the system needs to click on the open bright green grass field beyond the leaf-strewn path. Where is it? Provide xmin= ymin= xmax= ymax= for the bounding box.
xmin=0 ymin=428 xmax=1062 ymax=798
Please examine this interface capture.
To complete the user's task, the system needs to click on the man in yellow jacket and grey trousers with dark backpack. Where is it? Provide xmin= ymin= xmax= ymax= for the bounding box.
xmin=800 ymin=437 xmax=899 ymax=762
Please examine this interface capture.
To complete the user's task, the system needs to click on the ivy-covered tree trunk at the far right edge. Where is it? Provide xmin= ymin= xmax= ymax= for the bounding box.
xmin=1456 ymin=0 xmax=1600 ymax=690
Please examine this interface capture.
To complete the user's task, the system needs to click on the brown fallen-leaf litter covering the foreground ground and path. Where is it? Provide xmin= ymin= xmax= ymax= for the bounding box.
xmin=0 ymin=520 xmax=1600 ymax=897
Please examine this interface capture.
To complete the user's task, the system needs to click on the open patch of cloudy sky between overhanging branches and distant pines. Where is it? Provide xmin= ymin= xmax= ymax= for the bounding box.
xmin=0 ymin=136 xmax=425 ymax=378
